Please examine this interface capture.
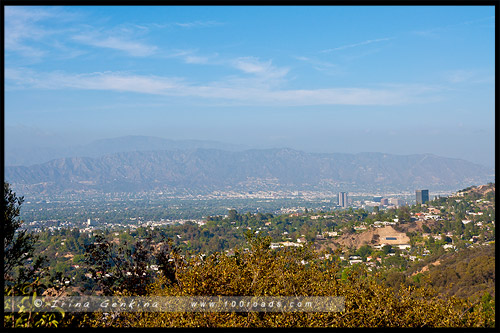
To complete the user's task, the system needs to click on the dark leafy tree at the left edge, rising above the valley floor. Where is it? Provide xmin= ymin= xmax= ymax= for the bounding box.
xmin=3 ymin=182 xmax=39 ymax=283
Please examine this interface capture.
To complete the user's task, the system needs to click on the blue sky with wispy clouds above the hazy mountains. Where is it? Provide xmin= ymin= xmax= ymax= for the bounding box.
xmin=4 ymin=6 xmax=495 ymax=166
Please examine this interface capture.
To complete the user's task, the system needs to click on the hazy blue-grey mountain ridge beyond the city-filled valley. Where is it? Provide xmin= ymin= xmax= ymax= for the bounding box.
xmin=5 ymin=148 xmax=494 ymax=193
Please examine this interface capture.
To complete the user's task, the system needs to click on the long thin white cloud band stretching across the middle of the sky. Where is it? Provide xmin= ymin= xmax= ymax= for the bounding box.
xmin=5 ymin=67 xmax=444 ymax=106
